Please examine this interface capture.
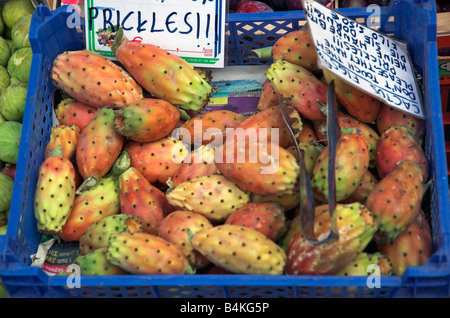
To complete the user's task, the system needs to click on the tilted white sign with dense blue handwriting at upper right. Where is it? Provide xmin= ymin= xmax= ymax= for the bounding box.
xmin=303 ymin=0 xmax=424 ymax=118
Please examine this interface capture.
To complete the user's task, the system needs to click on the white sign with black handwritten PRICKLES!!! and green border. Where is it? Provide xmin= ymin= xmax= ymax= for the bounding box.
xmin=84 ymin=0 xmax=226 ymax=68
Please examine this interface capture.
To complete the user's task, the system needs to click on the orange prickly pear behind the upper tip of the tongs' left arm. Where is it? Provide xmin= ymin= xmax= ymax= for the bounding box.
xmin=234 ymin=106 xmax=302 ymax=148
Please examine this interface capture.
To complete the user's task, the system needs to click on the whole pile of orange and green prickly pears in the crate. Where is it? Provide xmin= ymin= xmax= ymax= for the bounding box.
xmin=34 ymin=25 xmax=433 ymax=276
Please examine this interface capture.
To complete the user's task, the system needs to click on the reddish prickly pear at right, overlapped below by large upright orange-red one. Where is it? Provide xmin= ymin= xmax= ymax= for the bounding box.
xmin=375 ymin=126 xmax=429 ymax=182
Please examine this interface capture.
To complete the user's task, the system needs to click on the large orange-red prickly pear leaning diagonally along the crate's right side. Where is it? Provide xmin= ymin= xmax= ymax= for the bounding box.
xmin=366 ymin=159 xmax=423 ymax=244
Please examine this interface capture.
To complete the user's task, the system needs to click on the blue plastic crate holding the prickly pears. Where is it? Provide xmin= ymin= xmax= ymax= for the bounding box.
xmin=0 ymin=0 xmax=450 ymax=298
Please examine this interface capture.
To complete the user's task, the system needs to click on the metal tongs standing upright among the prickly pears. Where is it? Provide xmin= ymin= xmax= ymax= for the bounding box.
xmin=280 ymin=81 xmax=341 ymax=245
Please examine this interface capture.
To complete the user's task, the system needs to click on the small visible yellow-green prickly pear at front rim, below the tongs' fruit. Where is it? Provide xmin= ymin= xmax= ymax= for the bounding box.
xmin=336 ymin=252 xmax=393 ymax=276
